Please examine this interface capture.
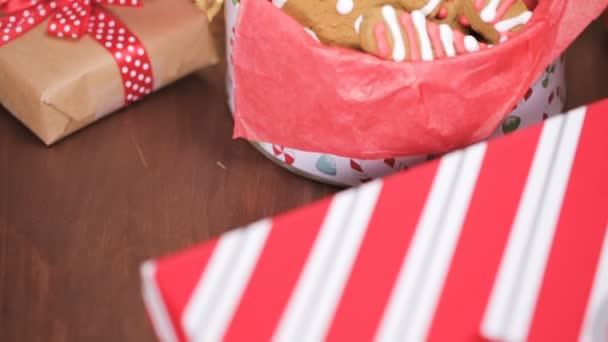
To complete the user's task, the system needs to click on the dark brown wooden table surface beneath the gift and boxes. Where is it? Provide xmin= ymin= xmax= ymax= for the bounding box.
xmin=0 ymin=17 xmax=608 ymax=342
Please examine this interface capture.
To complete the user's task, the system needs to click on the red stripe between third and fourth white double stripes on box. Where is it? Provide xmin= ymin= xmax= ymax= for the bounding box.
xmin=429 ymin=121 xmax=541 ymax=342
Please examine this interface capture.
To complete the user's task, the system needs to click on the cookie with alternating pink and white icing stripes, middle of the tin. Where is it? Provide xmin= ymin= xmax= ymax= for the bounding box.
xmin=360 ymin=5 xmax=487 ymax=62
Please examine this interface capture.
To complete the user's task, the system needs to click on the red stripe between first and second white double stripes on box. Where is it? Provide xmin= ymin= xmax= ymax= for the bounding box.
xmin=224 ymin=199 xmax=331 ymax=342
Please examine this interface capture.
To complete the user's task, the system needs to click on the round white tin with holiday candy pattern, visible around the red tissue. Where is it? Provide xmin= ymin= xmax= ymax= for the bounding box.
xmin=225 ymin=0 xmax=566 ymax=186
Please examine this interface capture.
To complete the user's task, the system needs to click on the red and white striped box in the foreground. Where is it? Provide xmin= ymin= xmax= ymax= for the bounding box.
xmin=142 ymin=100 xmax=608 ymax=342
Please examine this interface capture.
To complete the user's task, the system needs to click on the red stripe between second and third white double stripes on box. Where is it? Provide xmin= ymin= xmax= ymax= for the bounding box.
xmin=326 ymin=161 xmax=438 ymax=341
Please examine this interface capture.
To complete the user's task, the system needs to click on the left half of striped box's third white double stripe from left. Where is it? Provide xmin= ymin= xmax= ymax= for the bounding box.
xmin=375 ymin=152 xmax=463 ymax=342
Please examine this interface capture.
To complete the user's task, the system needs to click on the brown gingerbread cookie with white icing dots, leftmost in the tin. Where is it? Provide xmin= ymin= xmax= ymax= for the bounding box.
xmin=272 ymin=0 xmax=404 ymax=49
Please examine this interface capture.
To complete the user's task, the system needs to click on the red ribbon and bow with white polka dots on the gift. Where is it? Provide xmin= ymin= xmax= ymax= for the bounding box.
xmin=0 ymin=0 xmax=154 ymax=104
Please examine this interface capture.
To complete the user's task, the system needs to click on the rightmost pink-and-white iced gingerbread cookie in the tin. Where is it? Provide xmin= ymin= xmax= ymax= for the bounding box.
xmin=459 ymin=0 xmax=532 ymax=44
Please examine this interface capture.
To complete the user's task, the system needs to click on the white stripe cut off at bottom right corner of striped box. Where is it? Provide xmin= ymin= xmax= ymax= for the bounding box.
xmin=580 ymin=230 xmax=608 ymax=342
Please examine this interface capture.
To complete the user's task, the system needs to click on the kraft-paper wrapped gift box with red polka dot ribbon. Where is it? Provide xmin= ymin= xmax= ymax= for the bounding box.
xmin=0 ymin=0 xmax=217 ymax=144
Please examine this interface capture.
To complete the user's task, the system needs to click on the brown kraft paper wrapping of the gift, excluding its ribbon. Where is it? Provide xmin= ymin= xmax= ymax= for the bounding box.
xmin=0 ymin=0 xmax=218 ymax=145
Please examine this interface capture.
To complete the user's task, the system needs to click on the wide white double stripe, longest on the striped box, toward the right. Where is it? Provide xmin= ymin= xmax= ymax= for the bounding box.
xmin=482 ymin=109 xmax=585 ymax=341
